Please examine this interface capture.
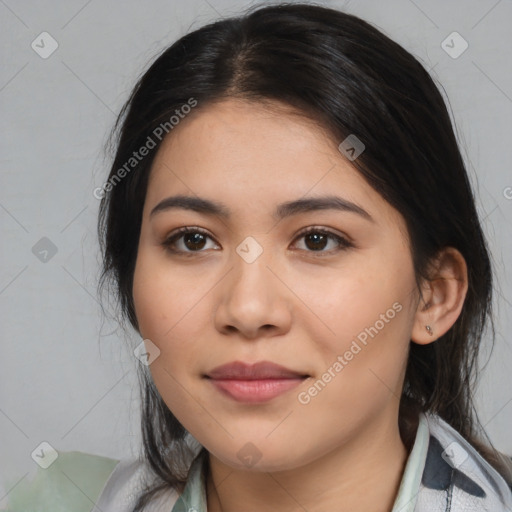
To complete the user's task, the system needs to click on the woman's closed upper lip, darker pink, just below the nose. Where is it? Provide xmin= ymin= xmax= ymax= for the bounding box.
xmin=206 ymin=361 xmax=308 ymax=380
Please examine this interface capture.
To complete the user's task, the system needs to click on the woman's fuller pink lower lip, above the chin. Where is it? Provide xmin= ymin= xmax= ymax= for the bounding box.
xmin=209 ymin=378 xmax=305 ymax=403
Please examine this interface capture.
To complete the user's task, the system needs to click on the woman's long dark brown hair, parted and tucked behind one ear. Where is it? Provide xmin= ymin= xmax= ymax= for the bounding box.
xmin=98 ymin=3 xmax=511 ymax=511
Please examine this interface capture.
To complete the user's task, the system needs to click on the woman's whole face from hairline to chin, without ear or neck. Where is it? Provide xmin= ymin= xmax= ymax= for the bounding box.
xmin=133 ymin=99 xmax=416 ymax=471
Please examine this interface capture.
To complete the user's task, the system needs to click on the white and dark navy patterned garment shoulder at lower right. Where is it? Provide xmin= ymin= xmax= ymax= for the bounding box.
xmin=418 ymin=414 xmax=512 ymax=512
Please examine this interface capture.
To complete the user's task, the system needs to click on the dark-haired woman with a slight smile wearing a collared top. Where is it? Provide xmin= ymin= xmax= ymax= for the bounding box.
xmin=76 ymin=4 xmax=512 ymax=512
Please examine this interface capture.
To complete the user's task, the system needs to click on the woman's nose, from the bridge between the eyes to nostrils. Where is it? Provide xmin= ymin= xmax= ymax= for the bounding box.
xmin=214 ymin=251 xmax=293 ymax=339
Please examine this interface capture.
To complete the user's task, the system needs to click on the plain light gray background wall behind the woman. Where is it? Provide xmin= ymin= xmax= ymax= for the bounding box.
xmin=0 ymin=0 xmax=512 ymax=505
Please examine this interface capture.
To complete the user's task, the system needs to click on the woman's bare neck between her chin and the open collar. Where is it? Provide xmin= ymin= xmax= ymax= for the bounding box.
xmin=206 ymin=412 xmax=408 ymax=512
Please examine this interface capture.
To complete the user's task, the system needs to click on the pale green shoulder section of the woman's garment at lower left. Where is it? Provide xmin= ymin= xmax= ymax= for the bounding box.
xmin=2 ymin=451 xmax=119 ymax=512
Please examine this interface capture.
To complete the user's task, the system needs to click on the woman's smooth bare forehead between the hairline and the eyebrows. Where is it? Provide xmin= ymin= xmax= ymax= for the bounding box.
xmin=146 ymin=99 xmax=400 ymax=230
